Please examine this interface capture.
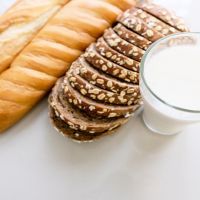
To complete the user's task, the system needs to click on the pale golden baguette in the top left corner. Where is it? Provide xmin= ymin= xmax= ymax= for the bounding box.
xmin=0 ymin=0 xmax=69 ymax=73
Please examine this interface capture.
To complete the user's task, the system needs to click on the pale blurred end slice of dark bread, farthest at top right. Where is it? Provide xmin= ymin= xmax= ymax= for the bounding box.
xmin=137 ymin=3 xmax=189 ymax=32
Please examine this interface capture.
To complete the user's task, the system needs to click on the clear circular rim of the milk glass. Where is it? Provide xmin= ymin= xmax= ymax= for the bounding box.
xmin=140 ymin=32 xmax=200 ymax=114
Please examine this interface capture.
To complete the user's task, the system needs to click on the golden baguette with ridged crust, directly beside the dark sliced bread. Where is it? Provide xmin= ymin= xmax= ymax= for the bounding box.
xmin=0 ymin=0 xmax=135 ymax=132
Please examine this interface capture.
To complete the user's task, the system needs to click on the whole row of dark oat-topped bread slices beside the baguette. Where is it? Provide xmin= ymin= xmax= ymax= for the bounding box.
xmin=49 ymin=3 xmax=188 ymax=141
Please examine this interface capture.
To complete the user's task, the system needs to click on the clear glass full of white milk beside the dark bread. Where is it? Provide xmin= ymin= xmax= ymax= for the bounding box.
xmin=140 ymin=33 xmax=200 ymax=135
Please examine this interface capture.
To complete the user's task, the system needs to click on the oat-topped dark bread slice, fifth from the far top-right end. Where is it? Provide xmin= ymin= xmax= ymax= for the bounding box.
xmin=95 ymin=37 xmax=140 ymax=72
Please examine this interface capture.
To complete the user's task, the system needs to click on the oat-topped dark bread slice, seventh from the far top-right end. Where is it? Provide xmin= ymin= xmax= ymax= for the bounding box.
xmin=75 ymin=57 xmax=140 ymax=95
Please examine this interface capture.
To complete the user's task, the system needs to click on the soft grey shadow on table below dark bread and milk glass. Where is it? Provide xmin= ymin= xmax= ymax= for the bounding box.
xmin=45 ymin=110 xmax=175 ymax=166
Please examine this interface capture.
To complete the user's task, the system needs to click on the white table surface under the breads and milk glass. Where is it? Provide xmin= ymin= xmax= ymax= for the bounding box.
xmin=0 ymin=0 xmax=200 ymax=200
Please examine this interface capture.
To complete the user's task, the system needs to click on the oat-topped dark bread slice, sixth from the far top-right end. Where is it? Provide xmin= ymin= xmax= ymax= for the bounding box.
xmin=84 ymin=44 xmax=139 ymax=84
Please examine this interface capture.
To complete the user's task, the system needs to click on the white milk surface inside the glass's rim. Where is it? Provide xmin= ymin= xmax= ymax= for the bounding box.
xmin=144 ymin=46 xmax=200 ymax=110
